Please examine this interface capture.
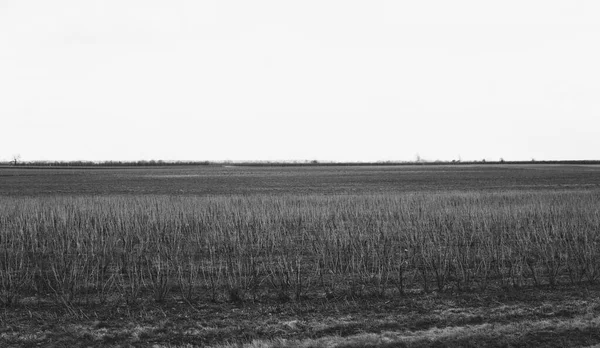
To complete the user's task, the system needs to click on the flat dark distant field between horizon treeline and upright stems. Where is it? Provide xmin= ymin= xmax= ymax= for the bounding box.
xmin=0 ymin=164 xmax=600 ymax=196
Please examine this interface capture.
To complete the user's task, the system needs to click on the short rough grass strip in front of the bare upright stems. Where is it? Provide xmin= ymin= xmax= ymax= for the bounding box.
xmin=0 ymin=287 xmax=600 ymax=348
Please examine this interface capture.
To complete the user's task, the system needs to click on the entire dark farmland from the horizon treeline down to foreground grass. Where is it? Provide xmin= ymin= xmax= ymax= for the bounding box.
xmin=0 ymin=164 xmax=600 ymax=347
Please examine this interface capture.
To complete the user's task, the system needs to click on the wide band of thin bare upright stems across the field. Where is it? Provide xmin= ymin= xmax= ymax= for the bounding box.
xmin=0 ymin=191 xmax=600 ymax=305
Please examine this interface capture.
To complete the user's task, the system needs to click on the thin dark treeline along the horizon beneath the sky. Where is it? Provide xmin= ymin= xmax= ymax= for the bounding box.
xmin=0 ymin=160 xmax=600 ymax=167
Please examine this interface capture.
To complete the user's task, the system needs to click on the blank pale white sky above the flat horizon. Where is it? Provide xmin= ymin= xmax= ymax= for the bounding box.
xmin=0 ymin=0 xmax=600 ymax=161
